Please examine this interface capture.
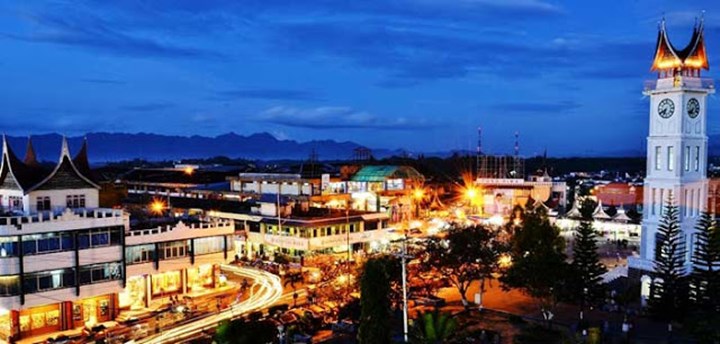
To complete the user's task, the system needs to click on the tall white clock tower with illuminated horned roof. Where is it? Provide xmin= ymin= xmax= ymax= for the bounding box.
xmin=628 ymin=20 xmax=715 ymax=288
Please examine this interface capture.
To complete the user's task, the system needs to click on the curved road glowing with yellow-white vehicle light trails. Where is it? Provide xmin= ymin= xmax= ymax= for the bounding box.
xmin=136 ymin=265 xmax=283 ymax=343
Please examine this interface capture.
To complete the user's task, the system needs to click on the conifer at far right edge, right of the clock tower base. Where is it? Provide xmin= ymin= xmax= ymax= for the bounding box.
xmin=690 ymin=212 xmax=720 ymax=312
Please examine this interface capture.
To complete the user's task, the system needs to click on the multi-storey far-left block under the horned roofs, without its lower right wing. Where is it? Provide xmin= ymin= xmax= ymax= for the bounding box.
xmin=0 ymin=139 xmax=128 ymax=340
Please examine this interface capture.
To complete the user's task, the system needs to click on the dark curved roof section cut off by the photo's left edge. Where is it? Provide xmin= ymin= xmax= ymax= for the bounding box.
xmin=0 ymin=135 xmax=46 ymax=192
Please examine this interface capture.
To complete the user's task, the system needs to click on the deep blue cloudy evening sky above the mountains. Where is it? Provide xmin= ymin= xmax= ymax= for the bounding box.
xmin=0 ymin=0 xmax=720 ymax=155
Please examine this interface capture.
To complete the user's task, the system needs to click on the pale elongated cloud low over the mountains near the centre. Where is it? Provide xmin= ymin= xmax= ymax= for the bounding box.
xmin=259 ymin=106 xmax=432 ymax=130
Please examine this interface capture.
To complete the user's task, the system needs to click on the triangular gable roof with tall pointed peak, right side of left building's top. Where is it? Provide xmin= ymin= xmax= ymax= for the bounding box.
xmin=28 ymin=137 xmax=100 ymax=191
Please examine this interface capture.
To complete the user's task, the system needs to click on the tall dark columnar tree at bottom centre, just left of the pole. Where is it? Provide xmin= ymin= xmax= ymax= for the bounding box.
xmin=358 ymin=257 xmax=391 ymax=344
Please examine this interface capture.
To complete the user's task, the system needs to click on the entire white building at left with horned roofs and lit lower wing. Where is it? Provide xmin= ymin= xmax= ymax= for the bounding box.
xmin=0 ymin=139 xmax=234 ymax=342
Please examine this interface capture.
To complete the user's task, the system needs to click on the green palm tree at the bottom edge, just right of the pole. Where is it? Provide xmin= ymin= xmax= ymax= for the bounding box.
xmin=410 ymin=309 xmax=457 ymax=344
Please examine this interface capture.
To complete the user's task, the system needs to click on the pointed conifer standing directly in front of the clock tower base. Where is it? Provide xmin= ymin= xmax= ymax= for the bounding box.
xmin=650 ymin=194 xmax=687 ymax=321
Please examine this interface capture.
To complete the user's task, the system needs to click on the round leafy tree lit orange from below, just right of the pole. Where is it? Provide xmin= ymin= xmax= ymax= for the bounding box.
xmin=423 ymin=226 xmax=503 ymax=306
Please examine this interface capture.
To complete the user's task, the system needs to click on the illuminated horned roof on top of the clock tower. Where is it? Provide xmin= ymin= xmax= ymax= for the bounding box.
xmin=650 ymin=19 xmax=710 ymax=71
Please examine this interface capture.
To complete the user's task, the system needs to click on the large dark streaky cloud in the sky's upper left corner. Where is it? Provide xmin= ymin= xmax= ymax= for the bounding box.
xmin=1 ymin=11 xmax=221 ymax=58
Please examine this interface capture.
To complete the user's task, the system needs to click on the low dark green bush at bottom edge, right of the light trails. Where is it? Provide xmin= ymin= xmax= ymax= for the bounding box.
xmin=213 ymin=319 xmax=278 ymax=344
